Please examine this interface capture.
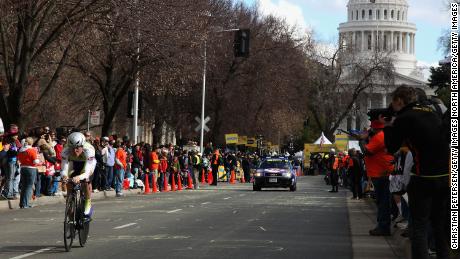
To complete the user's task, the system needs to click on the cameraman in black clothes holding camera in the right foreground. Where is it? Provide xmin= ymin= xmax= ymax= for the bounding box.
xmin=384 ymin=86 xmax=450 ymax=259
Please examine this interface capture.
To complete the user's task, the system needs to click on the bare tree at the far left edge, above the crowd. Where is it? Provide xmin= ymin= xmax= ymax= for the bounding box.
xmin=0 ymin=0 xmax=105 ymax=128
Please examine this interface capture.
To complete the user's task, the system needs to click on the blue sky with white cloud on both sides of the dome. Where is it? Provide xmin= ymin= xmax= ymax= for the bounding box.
xmin=242 ymin=0 xmax=450 ymax=70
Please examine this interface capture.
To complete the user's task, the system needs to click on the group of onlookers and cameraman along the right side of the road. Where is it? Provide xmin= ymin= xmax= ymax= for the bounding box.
xmin=310 ymin=86 xmax=450 ymax=259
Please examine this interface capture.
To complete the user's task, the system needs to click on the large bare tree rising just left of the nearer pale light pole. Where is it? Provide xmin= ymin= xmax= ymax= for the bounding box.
xmin=69 ymin=0 xmax=206 ymax=135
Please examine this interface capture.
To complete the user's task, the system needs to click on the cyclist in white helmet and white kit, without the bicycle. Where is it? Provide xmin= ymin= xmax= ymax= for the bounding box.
xmin=61 ymin=132 xmax=96 ymax=218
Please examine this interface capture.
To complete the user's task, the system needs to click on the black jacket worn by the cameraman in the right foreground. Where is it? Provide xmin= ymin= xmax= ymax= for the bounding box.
xmin=384 ymin=103 xmax=450 ymax=176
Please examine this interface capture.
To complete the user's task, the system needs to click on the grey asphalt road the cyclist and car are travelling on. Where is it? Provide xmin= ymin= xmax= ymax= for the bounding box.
xmin=0 ymin=176 xmax=352 ymax=259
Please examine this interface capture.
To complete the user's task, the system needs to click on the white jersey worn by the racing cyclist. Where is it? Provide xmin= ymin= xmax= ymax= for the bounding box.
xmin=61 ymin=143 xmax=97 ymax=180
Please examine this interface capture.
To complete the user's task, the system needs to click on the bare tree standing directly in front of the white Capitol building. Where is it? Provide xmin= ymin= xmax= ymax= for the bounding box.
xmin=308 ymin=42 xmax=394 ymax=138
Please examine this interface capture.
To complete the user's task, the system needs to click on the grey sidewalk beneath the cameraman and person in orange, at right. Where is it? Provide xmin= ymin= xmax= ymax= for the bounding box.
xmin=342 ymin=192 xmax=410 ymax=259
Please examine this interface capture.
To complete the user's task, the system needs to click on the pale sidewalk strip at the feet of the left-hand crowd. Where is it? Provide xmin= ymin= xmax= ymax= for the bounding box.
xmin=0 ymin=189 xmax=141 ymax=211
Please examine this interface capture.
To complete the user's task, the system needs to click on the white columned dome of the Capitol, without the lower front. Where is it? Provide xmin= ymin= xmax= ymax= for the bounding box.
xmin=338 ymin=0 xmax=423 ymax=80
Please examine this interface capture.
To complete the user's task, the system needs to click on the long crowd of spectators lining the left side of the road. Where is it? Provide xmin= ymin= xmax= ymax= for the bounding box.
xmin=0 ymin=127 xmax=266 ymax=205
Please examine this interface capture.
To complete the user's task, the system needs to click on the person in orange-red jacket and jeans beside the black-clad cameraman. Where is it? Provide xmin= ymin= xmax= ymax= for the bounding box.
xmin=359 ymin=109 xmax=394 ymax=236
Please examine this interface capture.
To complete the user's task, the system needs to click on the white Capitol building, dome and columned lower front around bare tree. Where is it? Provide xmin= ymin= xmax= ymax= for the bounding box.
xmin=338 ymin=0 xmax=433 ymax=130
